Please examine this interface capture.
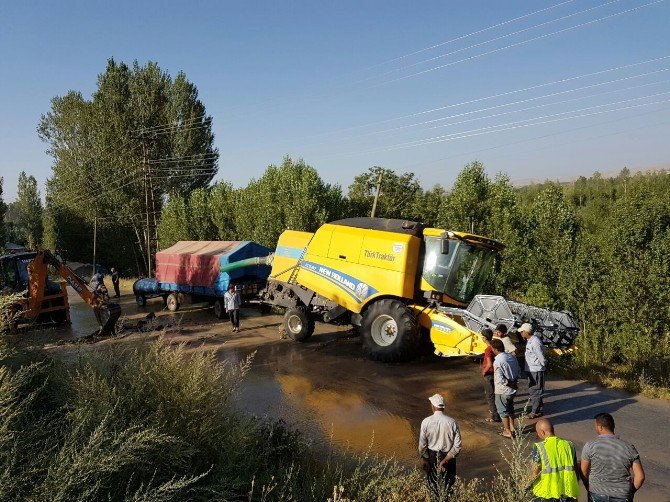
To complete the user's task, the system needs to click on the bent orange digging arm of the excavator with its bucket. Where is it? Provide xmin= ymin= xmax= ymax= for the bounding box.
xmin=28 ymin=249 xmax=121 ymax=336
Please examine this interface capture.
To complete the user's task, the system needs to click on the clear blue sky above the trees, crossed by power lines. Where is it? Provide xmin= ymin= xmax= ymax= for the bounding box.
xmin=0 ymin=0 xmax=670 ymax=200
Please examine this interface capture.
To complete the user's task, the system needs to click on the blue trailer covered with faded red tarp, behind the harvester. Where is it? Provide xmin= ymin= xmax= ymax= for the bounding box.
xmin=133 ymin=241 xmax=270 ymax=319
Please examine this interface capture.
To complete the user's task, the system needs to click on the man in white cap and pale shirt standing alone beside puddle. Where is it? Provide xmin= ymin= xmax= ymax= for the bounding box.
xmin=419 ymin=394 xmax=461 ymax=493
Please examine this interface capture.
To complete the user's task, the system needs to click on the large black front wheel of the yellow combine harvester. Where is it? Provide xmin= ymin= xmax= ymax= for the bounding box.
xmin=360 ymin=299 xmax=420 ymax=363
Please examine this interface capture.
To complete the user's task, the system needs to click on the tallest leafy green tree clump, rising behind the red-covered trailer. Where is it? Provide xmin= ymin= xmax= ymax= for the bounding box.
xmin=38 ymin=59 xmax=218 ymax=272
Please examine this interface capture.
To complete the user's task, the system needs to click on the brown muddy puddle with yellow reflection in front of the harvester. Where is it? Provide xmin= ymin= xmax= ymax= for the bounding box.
xmin=222 ymin=335 xmax=491 ymax=475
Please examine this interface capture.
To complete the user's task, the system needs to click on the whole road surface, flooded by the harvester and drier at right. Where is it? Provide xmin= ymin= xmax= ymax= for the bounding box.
xmin=40 ymin=295 xmax=670 ymax=502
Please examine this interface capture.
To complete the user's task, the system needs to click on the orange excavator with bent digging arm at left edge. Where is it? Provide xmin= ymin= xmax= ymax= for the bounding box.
xmin=0 ymin=249 xmax=121 ymax=336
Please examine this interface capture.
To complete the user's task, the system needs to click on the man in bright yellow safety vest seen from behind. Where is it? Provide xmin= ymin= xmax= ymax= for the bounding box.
xmin=532 ymin=418 xmax=579 ymax=502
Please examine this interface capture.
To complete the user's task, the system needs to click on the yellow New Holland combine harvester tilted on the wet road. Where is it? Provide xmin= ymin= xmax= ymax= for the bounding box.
xmin=262 ymin=218 xmax=571 ymax=362
